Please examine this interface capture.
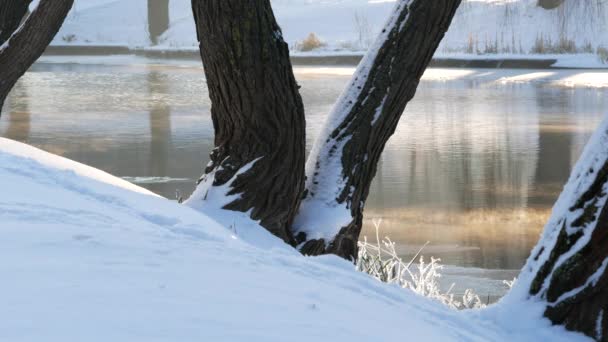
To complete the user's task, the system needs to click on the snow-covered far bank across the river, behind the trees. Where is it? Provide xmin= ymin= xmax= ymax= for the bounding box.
xmin=47 ymin=0 xmax=608 ymax=67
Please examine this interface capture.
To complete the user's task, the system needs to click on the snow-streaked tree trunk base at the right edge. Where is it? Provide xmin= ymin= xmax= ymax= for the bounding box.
xmin=514 ymin=118 xmax=608 ymax=341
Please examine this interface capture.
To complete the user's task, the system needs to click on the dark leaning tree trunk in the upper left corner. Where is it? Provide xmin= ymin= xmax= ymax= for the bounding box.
xmin=0 ymin=0 xmax=74 ymax=117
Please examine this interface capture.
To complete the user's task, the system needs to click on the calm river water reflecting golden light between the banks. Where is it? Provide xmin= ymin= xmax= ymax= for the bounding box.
xmin=0 ymin=57 xmax=608 ymax=300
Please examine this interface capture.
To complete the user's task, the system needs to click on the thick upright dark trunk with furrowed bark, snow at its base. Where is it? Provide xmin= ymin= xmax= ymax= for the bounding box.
xmin=187 ymin=0 xmax=306 ymax=243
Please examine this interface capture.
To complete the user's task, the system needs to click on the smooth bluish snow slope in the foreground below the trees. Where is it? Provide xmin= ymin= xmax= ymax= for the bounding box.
xmin=0 ymin=139 xmax=589 ymax=342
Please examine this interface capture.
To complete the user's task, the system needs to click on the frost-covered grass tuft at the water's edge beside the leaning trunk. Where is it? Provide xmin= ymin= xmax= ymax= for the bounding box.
xmin=357 ymin=219 xmax=486 ymax=309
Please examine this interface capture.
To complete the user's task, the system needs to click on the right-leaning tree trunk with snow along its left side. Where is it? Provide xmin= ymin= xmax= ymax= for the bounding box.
xmin=293 ymin=0 xmax=460 ymax=259
